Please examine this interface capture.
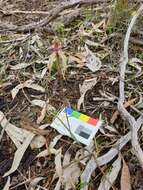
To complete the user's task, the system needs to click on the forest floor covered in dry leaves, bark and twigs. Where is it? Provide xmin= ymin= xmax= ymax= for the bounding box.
xmin=0 ymin=0 xmax=143 ymax=190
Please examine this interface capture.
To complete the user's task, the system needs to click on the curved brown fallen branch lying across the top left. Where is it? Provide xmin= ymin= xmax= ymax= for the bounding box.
xmin=0 ymin=0 xmax=109 ymax=32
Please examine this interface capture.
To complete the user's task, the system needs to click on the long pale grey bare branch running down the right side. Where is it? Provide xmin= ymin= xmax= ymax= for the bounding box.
xmin=118 ymin=4 xmax=143 ymax=168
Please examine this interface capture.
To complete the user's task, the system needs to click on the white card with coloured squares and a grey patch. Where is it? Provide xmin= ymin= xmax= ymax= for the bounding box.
xmin=51 ymin=107 xmax=102 ymax=145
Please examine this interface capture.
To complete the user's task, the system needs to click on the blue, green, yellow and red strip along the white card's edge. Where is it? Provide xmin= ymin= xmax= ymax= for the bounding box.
xmin=64 ymin=107 xmax=98 ymax=126
